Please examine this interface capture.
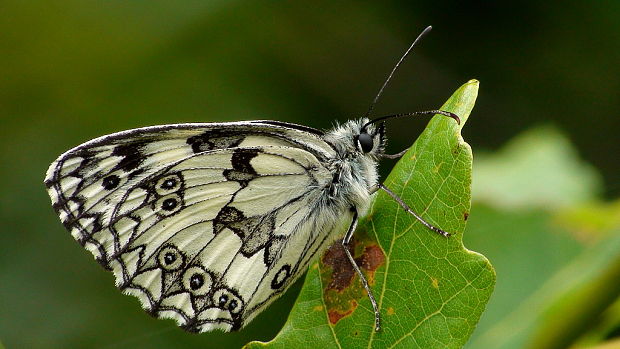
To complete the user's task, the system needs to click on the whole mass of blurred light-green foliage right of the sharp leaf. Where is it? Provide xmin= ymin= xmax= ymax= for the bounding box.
xmin=465 ymin=128 xmax=620 ymax=348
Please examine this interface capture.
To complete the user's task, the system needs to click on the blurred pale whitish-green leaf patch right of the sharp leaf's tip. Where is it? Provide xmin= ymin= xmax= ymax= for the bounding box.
xmin=473 ymin=127 xmax=601 ymax=210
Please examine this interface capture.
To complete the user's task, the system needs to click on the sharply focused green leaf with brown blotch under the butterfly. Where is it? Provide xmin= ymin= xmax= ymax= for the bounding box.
xmin=247 ymin=80 xmax=495 ymax=348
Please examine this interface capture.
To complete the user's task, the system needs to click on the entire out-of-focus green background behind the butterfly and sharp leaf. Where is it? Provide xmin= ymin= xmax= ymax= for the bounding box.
xmin=0 ymin=0 xmax=620 ymax=348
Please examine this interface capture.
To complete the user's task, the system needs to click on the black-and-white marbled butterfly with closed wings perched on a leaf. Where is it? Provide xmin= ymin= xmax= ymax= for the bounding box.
xmin=45 ymin=27 xmax=459 ymax=332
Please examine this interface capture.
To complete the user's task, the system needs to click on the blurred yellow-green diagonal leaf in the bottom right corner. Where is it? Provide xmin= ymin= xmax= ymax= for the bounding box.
xmin=471 ymin=229 xmax=620 ymax=349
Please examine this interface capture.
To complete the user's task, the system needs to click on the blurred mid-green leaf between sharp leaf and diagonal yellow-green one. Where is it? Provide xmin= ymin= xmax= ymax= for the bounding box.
xmin=464 ymin=204 xmax=585 ymax=349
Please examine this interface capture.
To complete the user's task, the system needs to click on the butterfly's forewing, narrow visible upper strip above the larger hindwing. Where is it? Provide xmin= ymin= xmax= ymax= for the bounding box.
xmin=45 ymin=121 xmax=333 ymax=252
